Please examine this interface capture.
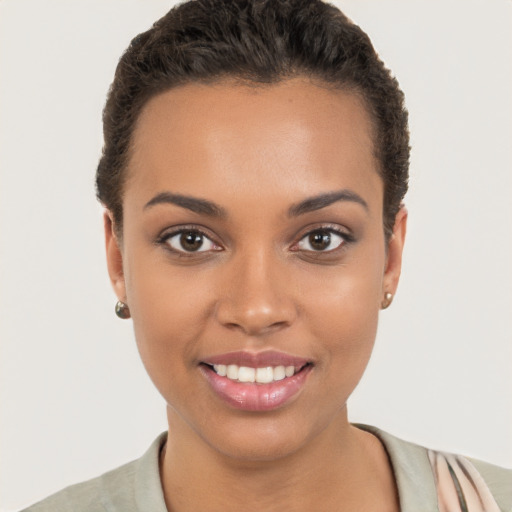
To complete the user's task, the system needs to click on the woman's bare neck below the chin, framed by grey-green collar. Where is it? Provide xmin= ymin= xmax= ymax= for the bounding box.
xmin=161 ymin=409 xmax=398 ymax=512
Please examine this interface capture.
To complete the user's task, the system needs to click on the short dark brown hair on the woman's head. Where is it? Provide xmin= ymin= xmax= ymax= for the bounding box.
xmin=96 ymin=0 xmax=410 ymax=236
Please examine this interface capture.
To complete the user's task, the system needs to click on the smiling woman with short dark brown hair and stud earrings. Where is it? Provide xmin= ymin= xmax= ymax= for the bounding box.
xmin=13 ymin=1 xmax=511 ymax=511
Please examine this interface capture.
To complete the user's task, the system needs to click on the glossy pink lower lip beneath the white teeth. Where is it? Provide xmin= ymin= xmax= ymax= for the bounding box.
xmin=201 ymin=365 xmax=312 ymax=411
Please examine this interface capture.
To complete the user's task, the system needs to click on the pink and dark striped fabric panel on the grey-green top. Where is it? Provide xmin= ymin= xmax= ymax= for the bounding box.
xmin=428 ymin=450 xmax=500 ymax=512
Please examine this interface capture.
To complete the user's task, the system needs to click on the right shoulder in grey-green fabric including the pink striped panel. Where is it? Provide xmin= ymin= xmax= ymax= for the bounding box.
xmin=356 ymin=425 xmax=512 ymax=512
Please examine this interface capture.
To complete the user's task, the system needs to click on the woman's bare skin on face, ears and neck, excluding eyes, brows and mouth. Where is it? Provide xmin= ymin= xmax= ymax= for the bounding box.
xmin=105 ymin=79 xmax=407 ymax=512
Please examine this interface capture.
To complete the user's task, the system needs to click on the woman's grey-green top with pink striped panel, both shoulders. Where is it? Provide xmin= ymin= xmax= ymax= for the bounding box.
xmin=22 ymin=425 xmax=512 ymax=512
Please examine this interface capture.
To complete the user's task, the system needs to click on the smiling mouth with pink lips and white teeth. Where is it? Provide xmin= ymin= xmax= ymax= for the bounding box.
xmin=199 ymin=352 xmax=314 ymax=411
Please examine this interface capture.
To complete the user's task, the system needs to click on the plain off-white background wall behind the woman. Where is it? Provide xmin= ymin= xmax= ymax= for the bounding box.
xmin=0 ymin=0 xmax=512 ymax=511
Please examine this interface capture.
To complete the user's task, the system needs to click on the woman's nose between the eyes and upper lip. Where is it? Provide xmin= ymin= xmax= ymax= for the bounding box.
xmin=216 ymin=251 xmax=297 ymax=336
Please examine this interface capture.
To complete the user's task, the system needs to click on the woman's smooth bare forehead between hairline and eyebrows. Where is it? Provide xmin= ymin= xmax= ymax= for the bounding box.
xmin=127 ymin=79 xmax=382 ymax=208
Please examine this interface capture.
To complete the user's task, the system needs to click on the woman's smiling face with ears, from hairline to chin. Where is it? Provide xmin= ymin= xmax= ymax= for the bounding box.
xmin=105 ymin=79 xmax=405 ymax=460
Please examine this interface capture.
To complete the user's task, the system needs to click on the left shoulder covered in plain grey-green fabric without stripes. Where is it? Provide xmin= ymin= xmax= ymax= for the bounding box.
xmin=21 ymin=434 xmax=166 ymax=512
